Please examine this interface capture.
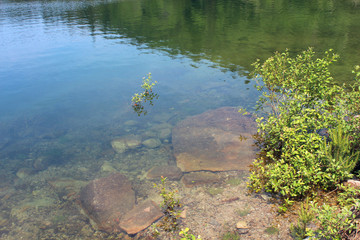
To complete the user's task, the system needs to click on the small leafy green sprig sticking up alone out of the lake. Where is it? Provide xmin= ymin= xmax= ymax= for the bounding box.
xmin=131 ymin=73 xmax=159 ymax=116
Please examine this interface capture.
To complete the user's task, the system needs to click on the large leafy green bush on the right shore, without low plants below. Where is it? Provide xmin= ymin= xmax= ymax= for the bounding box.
xmin=249 ymin=48 xmax=360 ymax=204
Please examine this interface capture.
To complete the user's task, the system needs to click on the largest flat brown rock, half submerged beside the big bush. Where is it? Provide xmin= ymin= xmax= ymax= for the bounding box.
xmin=172 ymin=107 xmax=257 ymax=172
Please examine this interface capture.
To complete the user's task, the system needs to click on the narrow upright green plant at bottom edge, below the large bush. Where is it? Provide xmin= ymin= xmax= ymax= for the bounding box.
xmin=290 ymin=198 xmax=315 ymax=240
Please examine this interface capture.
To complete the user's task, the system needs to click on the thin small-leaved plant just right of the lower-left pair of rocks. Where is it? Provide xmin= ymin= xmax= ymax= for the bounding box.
xmin=154 ymin=177 xmax=181 ymax=232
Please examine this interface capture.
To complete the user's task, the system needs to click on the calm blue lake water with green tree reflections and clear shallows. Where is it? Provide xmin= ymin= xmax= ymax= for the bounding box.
xmin=0 ymin=0 xmax=360 ymax=239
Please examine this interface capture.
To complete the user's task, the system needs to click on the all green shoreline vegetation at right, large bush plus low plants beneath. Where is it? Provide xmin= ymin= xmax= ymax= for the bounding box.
xmin=248 ymin=48 xmax=360 ymax=239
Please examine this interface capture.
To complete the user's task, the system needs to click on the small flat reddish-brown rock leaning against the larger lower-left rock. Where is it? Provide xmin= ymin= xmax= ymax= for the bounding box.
xmin=119 ymin=200 xmax=163 ymax=234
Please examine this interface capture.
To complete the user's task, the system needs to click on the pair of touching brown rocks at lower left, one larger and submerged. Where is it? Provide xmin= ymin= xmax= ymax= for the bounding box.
xmin=80 ymin=173 xmax=163 ymax=234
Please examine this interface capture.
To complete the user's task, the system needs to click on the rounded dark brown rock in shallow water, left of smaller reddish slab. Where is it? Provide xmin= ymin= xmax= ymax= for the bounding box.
xmin=80 ymin=173 xmax=135 ymax=232
